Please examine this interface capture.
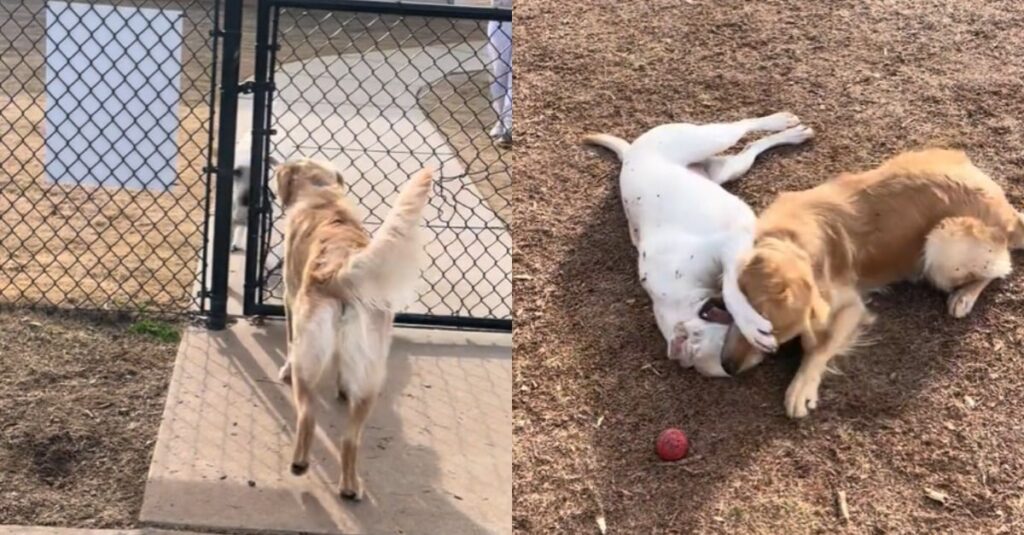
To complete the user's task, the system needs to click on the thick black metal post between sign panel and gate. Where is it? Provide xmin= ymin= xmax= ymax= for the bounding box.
xmin=207 ymin=0 xmax=242 ymax=330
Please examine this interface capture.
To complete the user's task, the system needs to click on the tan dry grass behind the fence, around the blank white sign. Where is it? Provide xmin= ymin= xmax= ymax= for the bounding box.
xmin=0 ymin=94 xmax=209 ymax=311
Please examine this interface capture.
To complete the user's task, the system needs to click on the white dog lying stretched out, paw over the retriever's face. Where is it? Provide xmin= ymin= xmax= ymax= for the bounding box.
xmin=585 ymin=113 xmax=813 ymax=376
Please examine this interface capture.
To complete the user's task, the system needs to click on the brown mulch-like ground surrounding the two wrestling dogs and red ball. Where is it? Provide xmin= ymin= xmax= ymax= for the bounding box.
xmin=512 ymin=0 xmax=1024 ymax=534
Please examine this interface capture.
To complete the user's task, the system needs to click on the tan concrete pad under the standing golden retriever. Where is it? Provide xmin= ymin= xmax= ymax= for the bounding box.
xmin=141 ymin=321 xmax=512 ymax=534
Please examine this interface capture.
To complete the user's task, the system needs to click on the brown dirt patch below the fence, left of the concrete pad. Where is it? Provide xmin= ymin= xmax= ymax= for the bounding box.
xmin=0 ymin=307 xmax=177 ymax=528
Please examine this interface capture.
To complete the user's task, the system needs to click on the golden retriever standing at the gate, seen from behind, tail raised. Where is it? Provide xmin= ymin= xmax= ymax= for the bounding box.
xmin=276 ymin=160 xmax=433 ymax=500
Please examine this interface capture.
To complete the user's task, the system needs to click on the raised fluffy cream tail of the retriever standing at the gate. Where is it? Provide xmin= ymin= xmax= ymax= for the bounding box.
xmin=331 ymin=169 xmax=434 ymax=311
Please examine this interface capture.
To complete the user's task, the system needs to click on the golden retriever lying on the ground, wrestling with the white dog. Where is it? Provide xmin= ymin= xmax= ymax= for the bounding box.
xmin=723 ymin=149 xmax=1024 ymax=418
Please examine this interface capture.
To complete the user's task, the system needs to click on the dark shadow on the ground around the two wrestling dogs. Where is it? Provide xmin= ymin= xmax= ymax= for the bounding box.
xmin=553 ymin=165 xmax=978 ymax=532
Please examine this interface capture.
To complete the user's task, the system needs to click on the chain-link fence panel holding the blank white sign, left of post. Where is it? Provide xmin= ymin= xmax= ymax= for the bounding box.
xmin=0 ymin=0 xmax=220 ymax=313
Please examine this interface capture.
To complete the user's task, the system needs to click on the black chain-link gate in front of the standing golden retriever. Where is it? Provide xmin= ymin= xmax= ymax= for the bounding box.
xmin=237 ymin=0 xmax=512 ymax=329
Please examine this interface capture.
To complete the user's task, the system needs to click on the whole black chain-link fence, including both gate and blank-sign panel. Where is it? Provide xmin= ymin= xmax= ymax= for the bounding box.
xmin=0 ymin=0 xmax=512 ymax=330
